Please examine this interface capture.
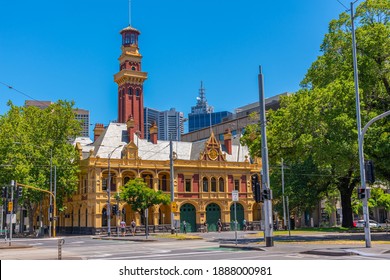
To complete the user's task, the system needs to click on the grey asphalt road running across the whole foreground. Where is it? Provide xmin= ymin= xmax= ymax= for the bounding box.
xmin=0 ymin=232 xmax=390 ymax=260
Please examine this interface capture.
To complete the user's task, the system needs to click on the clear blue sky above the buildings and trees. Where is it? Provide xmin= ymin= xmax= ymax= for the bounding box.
xmin=0 ymin=0 xmax=349 ymax=133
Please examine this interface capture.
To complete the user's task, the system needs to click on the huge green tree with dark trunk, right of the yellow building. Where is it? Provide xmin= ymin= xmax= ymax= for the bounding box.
xmin=243 ymin=0 xmax=390 ymax=227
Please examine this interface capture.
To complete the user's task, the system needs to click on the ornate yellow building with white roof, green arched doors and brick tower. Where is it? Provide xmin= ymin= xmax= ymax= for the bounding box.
xmin=58 ymin=26 xmax=261 ymax=234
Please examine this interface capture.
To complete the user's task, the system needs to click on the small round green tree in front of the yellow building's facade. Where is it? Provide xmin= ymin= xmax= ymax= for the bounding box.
xmin=120 ymin=178 xmax=170 ymax=223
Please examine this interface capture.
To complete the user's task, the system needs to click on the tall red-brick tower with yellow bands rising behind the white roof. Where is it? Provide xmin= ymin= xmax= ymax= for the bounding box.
xmin=114 ymin=26 xmax=148 ymax=137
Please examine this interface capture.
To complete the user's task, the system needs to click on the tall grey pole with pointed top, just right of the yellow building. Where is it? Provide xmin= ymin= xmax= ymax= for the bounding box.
xmin=258 ymin=66 xmax=274 ymax=247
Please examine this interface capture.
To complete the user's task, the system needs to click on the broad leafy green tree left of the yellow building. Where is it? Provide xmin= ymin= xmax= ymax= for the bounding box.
xmin=0 ymin=100 xmax=81 ymax=231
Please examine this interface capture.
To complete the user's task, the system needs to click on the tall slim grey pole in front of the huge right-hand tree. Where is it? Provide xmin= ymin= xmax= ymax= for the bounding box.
xmin=351 ymin=1 xmax=371 ymax=248
